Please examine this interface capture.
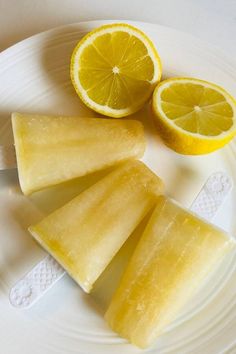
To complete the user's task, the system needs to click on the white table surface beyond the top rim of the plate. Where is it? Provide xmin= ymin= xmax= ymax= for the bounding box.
xmin=0 ymin=0 xmax=236 ymax=60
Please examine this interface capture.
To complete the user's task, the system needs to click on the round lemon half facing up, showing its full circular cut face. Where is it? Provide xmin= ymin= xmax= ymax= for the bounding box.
xmin=70 ymin=23 xmax=161 ymax=118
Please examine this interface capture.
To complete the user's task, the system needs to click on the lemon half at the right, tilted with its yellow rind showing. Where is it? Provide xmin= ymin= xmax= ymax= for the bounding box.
xmin=152 ymin=78 xmax=236 ymax=155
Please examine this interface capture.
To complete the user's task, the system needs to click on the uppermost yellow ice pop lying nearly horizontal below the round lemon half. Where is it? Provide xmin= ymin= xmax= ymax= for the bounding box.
xmin=12 ymin=113 xmax=145 ymax=195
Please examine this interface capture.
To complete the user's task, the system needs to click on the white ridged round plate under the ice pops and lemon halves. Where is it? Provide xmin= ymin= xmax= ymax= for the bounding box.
xmin=0 ymin=21 xmax=236 ymax=354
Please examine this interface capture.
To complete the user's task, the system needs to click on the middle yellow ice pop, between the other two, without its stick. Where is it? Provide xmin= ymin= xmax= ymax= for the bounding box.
xmin=29 ymin=160 xmax=163 ymax=292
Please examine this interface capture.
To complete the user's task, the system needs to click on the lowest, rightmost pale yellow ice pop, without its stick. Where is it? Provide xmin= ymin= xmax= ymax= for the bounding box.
xmin=105 ymin=197 xmax=235 ymax=348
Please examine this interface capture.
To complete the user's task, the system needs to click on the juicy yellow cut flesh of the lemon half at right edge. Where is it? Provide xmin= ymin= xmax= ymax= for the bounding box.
xmin=161 ymin=82 xmax=234 ymax=136
